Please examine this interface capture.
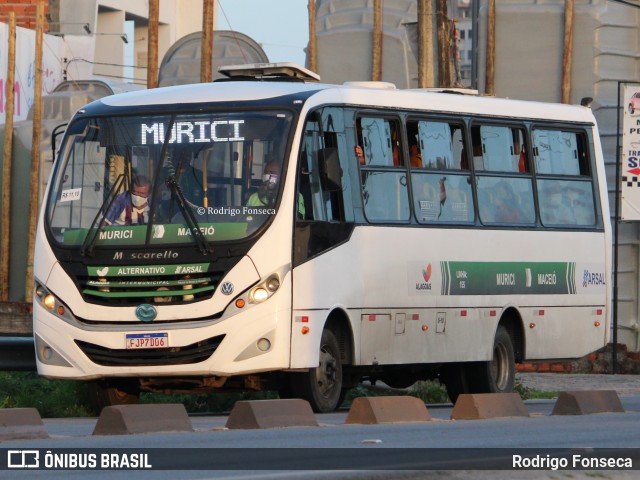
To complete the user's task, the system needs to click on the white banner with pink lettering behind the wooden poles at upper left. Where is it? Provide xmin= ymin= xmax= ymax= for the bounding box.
xmin=0 ymin=23 xmax=64 ymax=124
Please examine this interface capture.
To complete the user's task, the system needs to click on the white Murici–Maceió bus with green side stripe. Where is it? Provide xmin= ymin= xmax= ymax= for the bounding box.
xmin=33 ymin=64 xmax=611 ymax=412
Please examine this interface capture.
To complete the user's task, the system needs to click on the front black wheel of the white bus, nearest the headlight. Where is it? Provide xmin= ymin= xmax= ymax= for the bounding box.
xmin=291 ymin=330 xmax=345 ymax=413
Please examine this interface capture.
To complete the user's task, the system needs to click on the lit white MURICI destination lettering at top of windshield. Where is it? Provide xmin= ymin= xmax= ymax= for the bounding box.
xmin=140 ymin=120 xmax=244 ymax=145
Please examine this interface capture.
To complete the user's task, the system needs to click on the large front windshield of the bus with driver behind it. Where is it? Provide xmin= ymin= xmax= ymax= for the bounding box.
xmin=47 ymin=110 xmax=292 ymax=250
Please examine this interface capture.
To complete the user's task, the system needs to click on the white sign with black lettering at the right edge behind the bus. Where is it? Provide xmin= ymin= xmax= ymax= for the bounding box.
xmin=620 ymin=84 xmax=640 ymax=221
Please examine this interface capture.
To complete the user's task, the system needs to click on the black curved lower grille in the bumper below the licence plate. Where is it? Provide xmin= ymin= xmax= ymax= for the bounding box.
xmin=76 ymin=335 xmax=224 ymax=367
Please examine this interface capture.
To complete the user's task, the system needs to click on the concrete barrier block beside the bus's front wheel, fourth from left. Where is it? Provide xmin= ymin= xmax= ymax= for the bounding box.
xmin=345 ymin=396 xmax=431 ymax=424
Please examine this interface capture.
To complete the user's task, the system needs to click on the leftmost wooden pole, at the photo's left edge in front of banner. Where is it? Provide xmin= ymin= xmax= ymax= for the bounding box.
xmin=0 ymin=12 xmax=16 ymax=302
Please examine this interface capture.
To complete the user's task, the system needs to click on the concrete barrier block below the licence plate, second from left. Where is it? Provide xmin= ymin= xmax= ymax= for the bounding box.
xmin=93 ymin=403 xmax=193 ymax=435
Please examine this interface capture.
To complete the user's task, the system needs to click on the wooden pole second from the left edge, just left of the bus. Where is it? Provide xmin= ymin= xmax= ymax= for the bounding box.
xmin=25 ymin=0 xmax=45 ymax=302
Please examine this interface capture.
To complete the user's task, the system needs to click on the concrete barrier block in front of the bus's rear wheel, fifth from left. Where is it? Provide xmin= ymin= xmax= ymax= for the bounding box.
xmin=451 ymin=393 xmax=529 ymax=420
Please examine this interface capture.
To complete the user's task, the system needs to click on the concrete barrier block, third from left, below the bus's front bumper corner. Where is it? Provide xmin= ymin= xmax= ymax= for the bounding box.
xmin=226 ymin=398 xmax=318 ymax=429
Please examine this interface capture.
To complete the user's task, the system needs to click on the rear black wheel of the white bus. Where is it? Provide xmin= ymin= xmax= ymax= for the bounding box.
xmin=469 ymin=326 xmax=516 ymax=393
